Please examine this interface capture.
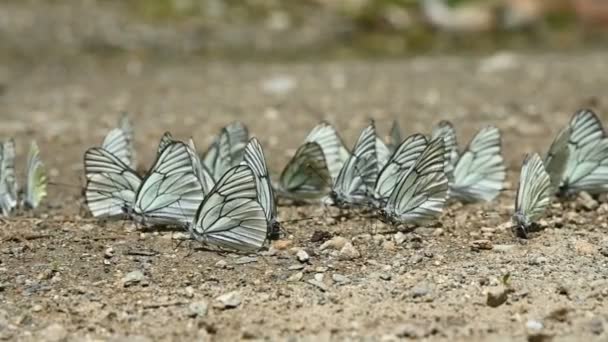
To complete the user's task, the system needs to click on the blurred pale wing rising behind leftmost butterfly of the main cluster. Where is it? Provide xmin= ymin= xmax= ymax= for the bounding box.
xmin=101 ymin=113 xmax=137 ymax=169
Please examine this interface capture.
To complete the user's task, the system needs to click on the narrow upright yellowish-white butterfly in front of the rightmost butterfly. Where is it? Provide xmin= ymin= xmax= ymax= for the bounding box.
xmin=512 ymin=153 xmax=552 ymax=238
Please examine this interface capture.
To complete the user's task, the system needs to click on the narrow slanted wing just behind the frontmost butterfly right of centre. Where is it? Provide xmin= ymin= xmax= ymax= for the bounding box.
xmin=374 ymin=134 xmax=428 ymax=203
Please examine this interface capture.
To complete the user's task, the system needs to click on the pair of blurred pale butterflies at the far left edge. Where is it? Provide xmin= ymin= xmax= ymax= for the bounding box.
xmin=0 ymin=139 xmax=47 ymax=217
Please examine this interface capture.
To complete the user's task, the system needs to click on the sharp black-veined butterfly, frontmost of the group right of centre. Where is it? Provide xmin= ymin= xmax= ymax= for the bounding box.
xmin=380 ymin=139 xmax=448 ymax=224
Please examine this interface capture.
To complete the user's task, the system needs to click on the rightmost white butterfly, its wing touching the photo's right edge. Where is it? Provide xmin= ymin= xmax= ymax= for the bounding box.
xmin=559 ymin=109 xmax=608 ymax=195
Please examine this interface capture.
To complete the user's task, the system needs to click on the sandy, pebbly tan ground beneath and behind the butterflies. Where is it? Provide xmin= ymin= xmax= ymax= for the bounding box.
xmin=0 ymin=52 xmax=608 ymax=341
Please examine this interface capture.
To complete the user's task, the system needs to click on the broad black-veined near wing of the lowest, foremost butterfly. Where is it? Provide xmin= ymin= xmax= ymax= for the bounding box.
xmin=189 ymin=165 xmax=268 ymax=252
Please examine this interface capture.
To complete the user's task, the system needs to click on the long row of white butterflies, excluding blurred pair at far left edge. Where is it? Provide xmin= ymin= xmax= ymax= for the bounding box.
xmin=84 ymin=110 xmax=608 ymax=251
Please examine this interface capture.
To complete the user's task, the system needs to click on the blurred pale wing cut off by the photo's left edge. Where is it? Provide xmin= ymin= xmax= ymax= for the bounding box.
xmin=0 ymin=138 xmax=19 ymax=216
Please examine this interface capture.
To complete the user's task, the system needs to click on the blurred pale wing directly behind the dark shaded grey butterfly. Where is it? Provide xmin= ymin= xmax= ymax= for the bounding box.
xmin=304 ymin=122 xmax=350 ymax=180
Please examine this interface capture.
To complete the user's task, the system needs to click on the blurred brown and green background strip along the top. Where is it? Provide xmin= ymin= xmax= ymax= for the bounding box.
xmin=0 ymin=0 xmax=608 ymax=60
